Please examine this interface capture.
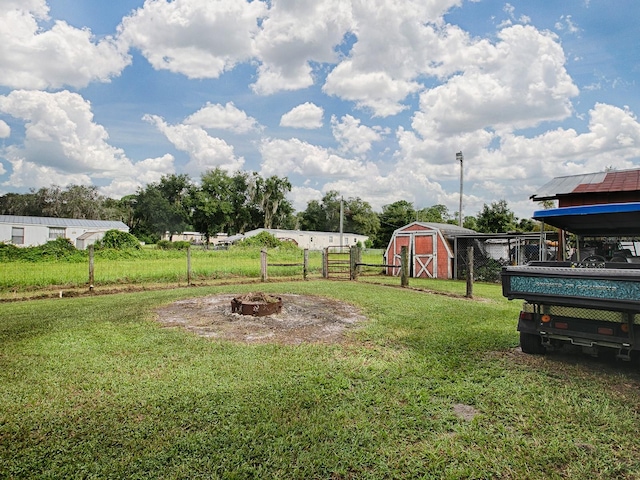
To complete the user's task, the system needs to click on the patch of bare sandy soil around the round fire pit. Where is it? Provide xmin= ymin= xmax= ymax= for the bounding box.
xmin=157 ymin=295 xmax=366 ymax=344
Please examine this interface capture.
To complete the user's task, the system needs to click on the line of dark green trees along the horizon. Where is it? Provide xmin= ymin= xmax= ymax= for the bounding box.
xmin=0 ymin=168 xmax=536 ymax=248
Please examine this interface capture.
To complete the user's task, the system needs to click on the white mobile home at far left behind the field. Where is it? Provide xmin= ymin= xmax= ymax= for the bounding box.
xmin=0 ymin=215 xmax=129 ymax=250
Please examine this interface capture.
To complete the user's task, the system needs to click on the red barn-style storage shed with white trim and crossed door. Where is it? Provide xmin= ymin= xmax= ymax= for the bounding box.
xmin=384 ymin=222 xmax=476 ymax=279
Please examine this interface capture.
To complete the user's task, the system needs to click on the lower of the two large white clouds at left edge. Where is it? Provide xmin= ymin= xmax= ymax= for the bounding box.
xmin=0 ymin=90 xmax=132 ymax=180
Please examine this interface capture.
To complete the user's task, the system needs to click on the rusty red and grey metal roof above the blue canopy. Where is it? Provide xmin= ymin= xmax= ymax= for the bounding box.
xmin=529 ymin=169 xmax=640 ymax=201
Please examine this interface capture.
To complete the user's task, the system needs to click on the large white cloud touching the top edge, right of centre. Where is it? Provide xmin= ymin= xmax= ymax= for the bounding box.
xmin=323 ymin=0 xmax=464 ymax=117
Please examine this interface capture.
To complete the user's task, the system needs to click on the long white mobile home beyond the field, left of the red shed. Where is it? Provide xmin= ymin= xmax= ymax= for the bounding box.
xmin=227 ymin=228 xmax=369 ymax=250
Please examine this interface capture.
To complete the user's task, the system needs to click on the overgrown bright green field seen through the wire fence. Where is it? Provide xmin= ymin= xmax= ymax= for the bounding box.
xmin=0 ymin=247 xmax=382 ymax=296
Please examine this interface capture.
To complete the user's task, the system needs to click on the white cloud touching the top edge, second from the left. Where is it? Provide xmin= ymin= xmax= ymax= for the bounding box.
xmin=119 ymin=0 xmax=267 ymax=78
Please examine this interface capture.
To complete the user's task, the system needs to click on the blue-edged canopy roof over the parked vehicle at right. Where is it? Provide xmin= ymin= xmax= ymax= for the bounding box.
xmin=533 ymin=202 xmax=640 ymax=236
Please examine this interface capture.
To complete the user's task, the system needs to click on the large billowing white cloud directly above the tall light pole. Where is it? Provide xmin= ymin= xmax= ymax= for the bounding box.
xmin=412 ymin=25 xmax=578 ymax=138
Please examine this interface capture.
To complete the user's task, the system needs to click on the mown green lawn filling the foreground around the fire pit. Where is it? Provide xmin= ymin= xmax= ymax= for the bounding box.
xmin=0 ymin=280 xmax=640 ymax=479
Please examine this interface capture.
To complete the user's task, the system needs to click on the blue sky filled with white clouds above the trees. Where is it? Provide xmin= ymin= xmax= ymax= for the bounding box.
xmin=0 ymin=0 xmax=640 ymax=218
